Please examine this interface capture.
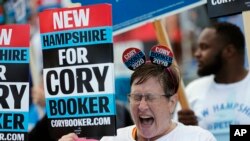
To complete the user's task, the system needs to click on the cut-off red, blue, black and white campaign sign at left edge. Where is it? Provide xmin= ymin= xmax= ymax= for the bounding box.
xmin=0 ymin=24 xmax=30 ymax=141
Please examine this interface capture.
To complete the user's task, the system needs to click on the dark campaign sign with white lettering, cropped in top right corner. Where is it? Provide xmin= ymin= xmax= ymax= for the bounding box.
xmin=207 ymin=0 xmax=250 ymax=18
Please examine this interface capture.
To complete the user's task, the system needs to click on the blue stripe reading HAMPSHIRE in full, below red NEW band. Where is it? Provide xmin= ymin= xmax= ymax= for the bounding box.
xmin=41 ymin=26 xmax=113 ymax=49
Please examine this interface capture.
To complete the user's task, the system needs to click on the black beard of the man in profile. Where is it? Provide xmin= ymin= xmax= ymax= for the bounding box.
xmin=197 ymin=51 xmax=223 ymax=76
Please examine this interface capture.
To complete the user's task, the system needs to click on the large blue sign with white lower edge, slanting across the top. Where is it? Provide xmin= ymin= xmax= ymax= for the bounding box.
xmin=71 ymin=0 xmax=206 ymax=35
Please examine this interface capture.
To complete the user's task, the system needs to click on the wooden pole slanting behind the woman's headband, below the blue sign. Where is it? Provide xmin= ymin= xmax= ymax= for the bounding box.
xmin=153 ymin=20 xmax=189 ymax=109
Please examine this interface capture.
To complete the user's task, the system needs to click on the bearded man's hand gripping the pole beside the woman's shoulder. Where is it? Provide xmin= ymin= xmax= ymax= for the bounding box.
xmin=178 ymin=109 xmax=198 ymax=125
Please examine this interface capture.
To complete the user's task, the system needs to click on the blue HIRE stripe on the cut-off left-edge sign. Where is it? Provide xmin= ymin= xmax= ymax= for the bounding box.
xmin=0 ymin=47 xmax=30 ymax=63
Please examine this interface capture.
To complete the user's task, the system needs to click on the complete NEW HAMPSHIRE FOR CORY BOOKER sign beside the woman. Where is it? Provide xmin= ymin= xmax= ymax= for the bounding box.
xmin=39 ymin=4 xmax=116 ymax=138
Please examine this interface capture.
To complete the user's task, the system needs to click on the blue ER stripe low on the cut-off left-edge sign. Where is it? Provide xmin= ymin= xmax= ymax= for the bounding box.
xmin=0 ymin=111 xmax=29 ymax=132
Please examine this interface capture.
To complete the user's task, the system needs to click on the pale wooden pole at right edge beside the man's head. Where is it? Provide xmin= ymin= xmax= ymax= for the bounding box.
xmin=242 ymin=11 xmax=250 ymax=68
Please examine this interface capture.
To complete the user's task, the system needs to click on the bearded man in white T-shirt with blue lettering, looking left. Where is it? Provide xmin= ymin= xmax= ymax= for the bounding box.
xmin=178 ymin=22 xmax=250 ymax=141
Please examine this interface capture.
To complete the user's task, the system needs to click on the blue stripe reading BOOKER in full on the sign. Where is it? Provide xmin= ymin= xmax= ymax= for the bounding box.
xmin=46 ymin=94 xmax=116 ymax=118
